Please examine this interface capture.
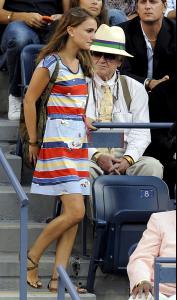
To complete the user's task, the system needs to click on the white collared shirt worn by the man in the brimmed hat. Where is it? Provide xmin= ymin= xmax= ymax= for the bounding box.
xmin=86 ymin=74 xmax=151 ymax=162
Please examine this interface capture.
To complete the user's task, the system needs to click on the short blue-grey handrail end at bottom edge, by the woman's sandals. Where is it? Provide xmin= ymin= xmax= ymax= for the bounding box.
xmin=57 ymin=265 xmax=81 ymax=300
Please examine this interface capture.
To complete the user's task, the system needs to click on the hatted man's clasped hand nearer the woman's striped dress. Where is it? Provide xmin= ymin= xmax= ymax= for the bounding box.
xmin=97 ymin=154 xmax=118 ymax=174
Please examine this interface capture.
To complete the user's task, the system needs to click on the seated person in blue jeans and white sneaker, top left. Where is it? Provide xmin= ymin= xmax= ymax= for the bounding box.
xmin=0 ymin=0 xmax=68 ymax=120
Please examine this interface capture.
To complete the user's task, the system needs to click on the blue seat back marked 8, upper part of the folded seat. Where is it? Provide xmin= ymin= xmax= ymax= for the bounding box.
xmin=93 ymin=176 xmax=170 ymax=222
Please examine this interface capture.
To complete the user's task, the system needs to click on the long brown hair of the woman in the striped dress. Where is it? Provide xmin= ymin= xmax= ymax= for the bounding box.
xmin=37 ymin=7 xmax=95 ymax=77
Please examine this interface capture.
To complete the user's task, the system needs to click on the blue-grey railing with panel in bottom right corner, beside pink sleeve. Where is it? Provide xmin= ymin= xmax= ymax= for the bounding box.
xmin=154 ymin=257 xmax=176 ymax=300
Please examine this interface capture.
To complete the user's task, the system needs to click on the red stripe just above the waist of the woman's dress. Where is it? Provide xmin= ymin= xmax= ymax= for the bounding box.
xmin=47 ymin=106 xmax=85 ymax=115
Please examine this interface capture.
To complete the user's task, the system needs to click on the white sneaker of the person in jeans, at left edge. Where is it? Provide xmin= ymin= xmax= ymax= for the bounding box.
xmin=8 ymin=95 xmax=22 ymax=121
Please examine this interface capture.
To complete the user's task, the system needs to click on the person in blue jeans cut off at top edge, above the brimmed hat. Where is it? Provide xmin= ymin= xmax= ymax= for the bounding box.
xmin=107 ymin=0 xmax=137 ymax=26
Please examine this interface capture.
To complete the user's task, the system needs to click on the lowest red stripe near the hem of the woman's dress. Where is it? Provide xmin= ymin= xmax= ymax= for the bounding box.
xmin=34 ymin=169 xmax=89 ymax=179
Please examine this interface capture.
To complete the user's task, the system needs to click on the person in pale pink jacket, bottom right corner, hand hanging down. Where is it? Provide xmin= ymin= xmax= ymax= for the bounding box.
xmin=128 ymin=211 xmax=176 ymax=300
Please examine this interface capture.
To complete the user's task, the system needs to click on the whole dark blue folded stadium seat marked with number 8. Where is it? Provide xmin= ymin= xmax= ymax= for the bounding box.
xmin=87 ymin=176 xmax=170 ymax=292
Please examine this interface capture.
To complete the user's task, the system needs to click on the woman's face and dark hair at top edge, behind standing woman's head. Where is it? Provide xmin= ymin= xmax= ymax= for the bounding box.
xmin=70 ymin=0 xmax=108 ymax=25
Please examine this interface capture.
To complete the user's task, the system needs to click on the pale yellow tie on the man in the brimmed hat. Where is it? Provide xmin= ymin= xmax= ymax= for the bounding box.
xmin=99 ymin=85 xmax=114 ymax=122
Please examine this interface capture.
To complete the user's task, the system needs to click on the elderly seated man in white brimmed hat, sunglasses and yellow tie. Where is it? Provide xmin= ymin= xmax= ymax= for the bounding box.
xmin=87 ymin=24 xmax=163 ymax=178
